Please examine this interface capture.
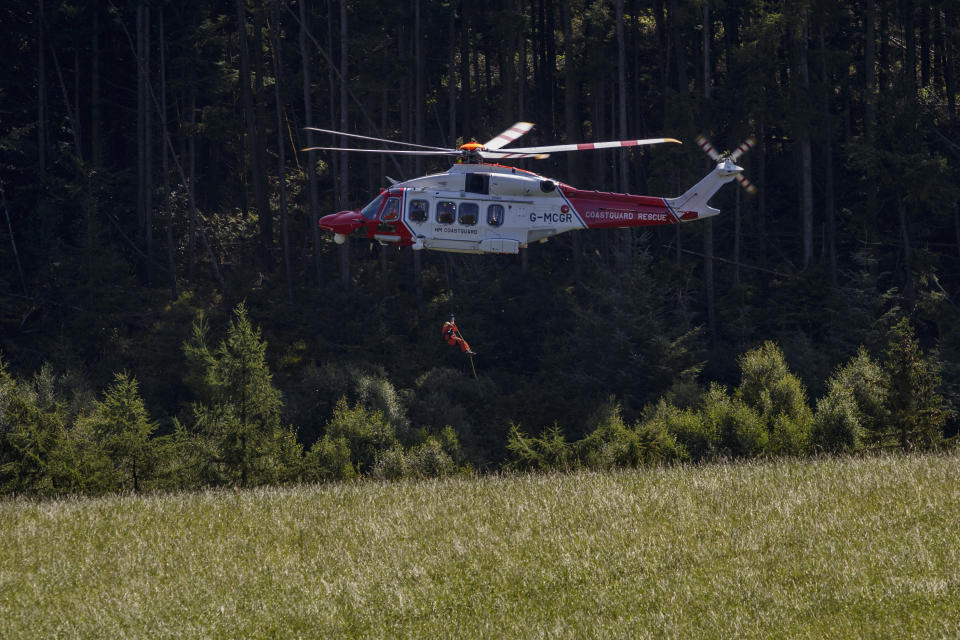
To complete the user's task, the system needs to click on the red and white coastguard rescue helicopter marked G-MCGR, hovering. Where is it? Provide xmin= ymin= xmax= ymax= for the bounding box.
xmin=304 ymin=122 xmax=755 ymax=254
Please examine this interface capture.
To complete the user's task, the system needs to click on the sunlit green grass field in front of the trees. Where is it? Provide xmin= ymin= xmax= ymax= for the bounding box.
xmin=0 ymin=455 xmax=960 ymax=640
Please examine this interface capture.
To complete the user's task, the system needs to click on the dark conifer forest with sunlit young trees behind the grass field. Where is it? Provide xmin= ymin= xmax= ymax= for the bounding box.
xmin=0 ymin=0 xmax=960 ymax=494
